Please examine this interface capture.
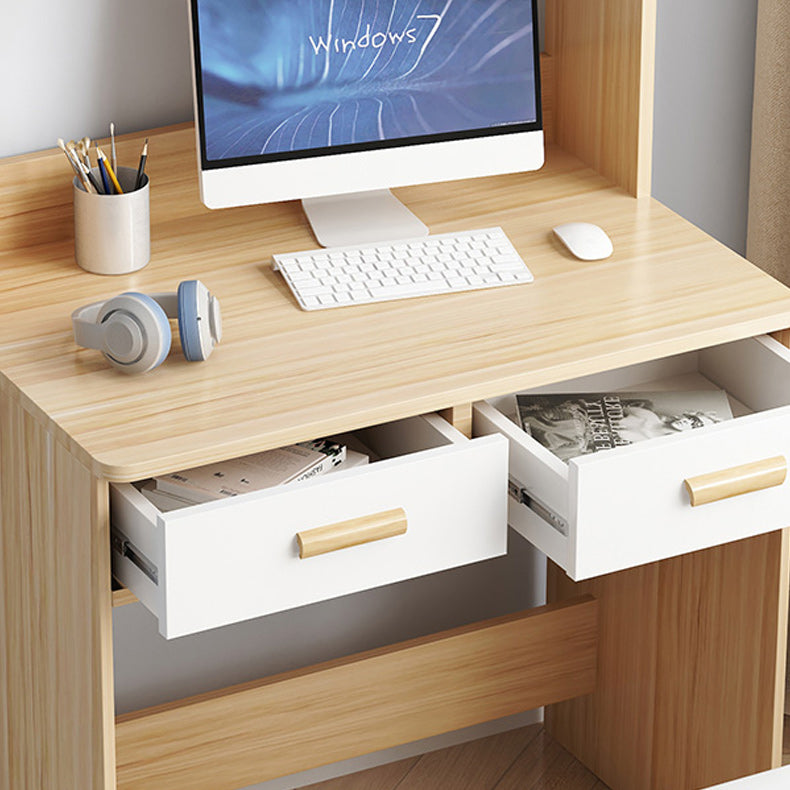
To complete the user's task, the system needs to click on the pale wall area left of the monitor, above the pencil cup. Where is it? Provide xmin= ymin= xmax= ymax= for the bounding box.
xmin=0 ymin=0 xmax=192 ymax=159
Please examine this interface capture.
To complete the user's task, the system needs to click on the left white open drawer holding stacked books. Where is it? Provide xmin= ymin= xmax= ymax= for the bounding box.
xmin=110 ymin=415 xmax=507 ymax=638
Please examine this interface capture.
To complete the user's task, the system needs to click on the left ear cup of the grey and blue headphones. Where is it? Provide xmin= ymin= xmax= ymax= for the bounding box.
xmin=97 ymin=292 xmax=171 ymax=373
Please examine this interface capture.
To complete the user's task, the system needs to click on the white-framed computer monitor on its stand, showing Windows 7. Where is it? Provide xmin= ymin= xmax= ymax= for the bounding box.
xmin=190 ymin=0 xmax=543 ymax=246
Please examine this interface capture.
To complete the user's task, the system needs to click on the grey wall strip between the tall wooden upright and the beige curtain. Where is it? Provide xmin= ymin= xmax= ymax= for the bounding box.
xmin=653 ymin=0 xmax=757 ymax=254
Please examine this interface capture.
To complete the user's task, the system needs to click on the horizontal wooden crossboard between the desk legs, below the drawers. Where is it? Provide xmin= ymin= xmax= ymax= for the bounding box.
xmin=116 ymin=596 xmax=597 ymax=790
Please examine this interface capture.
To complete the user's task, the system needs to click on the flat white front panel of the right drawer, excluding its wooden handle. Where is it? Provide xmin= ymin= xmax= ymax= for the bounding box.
xmin=569 ymin=407 xmax=790 ymax=579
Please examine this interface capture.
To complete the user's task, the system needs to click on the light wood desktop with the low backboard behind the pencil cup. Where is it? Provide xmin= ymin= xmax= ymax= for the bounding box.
xmin=0 ymin=126 xmax=790 ymax=480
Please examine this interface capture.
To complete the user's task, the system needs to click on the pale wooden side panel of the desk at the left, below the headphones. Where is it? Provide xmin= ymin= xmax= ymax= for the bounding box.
xmin=0 ymin=390 xmax=115 ymax=790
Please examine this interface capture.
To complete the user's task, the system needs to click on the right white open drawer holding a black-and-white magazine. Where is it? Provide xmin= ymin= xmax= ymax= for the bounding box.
xmin=474 ymin=337 xmax=790 ymax=580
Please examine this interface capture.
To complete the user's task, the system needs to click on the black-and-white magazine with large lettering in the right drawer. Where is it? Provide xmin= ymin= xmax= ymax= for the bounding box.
xmin=516 ymin=389 xmax=732 ymax=461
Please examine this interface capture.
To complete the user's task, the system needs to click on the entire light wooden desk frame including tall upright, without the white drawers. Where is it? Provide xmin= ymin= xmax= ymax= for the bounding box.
xmin=0 ymin=0 xmax=790 ymax=790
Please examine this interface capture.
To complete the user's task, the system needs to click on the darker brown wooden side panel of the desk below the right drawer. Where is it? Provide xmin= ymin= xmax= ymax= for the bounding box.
xmin=546 ymin=530 xmax=790 ymax=790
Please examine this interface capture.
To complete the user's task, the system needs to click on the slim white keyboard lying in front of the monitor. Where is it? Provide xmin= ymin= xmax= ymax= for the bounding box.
xmin=272 ymin=228 xmax=534 ymax=310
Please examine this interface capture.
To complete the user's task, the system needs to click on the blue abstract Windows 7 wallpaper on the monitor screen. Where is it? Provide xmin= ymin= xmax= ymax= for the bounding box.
xmin=198 ymin=0 xmax=537 ymax=161
